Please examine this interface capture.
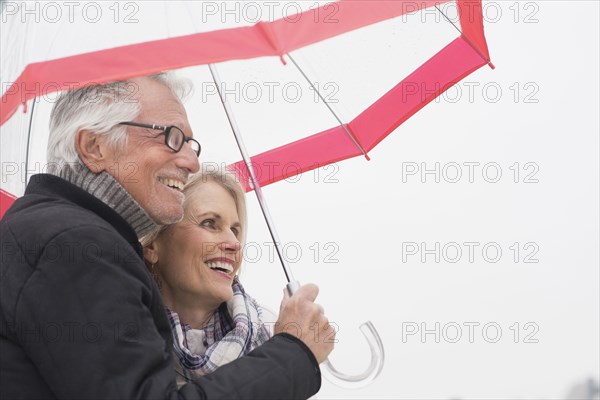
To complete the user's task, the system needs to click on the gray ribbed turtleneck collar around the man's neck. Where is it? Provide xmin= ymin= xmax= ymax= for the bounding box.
xmin=56 ymin=164 xmax=158 ymax=238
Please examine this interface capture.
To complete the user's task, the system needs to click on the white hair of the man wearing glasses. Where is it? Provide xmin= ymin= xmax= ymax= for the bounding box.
xmin=46 ymin=72 xmax=192 ymax=174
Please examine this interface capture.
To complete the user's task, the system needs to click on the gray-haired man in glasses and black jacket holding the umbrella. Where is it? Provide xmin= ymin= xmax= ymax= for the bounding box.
xmin=0 ymin=74 xmax=333 ymax=399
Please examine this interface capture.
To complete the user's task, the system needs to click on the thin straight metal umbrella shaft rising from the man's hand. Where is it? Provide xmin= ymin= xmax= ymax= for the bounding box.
xmin=208 ymin=64 xmax=295 ymax=282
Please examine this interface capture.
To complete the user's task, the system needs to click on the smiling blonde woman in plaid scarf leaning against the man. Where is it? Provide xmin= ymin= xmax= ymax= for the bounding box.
xmin=142 ymin=172 xmax=269 ymax=383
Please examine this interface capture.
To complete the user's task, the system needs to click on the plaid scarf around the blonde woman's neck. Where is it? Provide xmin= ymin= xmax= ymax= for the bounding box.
xmin=166 ymin=278 xmax=270 ymax=381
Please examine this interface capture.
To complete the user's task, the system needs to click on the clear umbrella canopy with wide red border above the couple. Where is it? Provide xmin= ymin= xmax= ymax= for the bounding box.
xmin=0 ymin=0 xmax=489 ymax=209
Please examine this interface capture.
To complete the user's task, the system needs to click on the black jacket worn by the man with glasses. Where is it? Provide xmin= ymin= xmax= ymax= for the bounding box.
xmin=0 ymin=174 xmax=321 ymax=400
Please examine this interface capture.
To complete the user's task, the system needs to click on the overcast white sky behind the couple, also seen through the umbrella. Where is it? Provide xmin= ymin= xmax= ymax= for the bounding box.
xmin=0 ymin=1 xmax=600 ymax=399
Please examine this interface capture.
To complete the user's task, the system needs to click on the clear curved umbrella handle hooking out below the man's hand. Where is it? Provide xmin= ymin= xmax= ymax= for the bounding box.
xmin=287 ymin=281 xmax=385 ymax=388
